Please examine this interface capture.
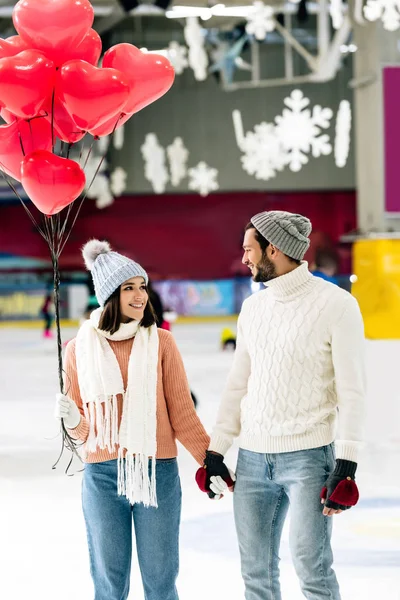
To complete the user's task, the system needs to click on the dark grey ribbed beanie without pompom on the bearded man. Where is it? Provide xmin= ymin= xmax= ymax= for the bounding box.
xmin=250 ymin=210 xmax=312 ymax=260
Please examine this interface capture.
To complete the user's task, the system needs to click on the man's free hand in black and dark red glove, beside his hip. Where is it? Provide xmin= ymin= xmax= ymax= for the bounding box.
xmin=320 ymin=458 xmax=359 ymax=517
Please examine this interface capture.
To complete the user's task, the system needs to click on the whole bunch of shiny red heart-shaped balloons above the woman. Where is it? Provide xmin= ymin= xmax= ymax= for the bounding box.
xmin=0 ymin=0 xmax=175 ymax=215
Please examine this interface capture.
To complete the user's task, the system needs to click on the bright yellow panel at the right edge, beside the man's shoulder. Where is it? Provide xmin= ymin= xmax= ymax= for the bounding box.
xmin=352 ymin=239 xmax=400 ymax=340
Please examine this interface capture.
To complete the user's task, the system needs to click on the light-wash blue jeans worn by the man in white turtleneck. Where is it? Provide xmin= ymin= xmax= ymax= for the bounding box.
xmin=233 ymin=444 xmax=340 ymax=600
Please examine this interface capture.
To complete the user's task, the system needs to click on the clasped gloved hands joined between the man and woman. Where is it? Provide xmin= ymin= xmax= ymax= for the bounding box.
xmin=196 ymin=450 xmax=236 ymax=500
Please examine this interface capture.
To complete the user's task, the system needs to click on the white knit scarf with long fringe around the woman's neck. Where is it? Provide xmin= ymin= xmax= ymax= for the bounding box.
xmin=76 ymin=308 xmax=158 ymax=506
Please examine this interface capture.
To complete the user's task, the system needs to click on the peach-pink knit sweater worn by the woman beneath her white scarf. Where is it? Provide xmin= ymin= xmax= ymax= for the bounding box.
xmin=65 ymin=329 xmax=210 ymax=465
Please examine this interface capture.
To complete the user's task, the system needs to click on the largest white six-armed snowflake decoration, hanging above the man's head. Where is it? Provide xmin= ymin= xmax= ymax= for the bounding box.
xmin=275 ymin=90 xmax=333 ymax=172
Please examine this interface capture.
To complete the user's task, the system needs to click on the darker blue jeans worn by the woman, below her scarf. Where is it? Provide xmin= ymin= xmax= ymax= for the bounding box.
xmin=82 ymin=458 xmax=182 ymax=600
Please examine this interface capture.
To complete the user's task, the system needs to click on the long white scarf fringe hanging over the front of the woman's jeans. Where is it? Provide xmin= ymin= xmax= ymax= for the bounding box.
xmin=118 ymin=448 xmax=158 ymax=508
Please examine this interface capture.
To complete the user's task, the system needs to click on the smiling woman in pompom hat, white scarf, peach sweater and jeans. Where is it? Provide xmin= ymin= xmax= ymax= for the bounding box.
xmin=56 ymin=240 xmax=209 ymax=600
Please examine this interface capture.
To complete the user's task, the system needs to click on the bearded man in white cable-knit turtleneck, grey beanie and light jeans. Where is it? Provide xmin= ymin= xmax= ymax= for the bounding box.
xmin=197 ymin=211 xmax=364 ymax=600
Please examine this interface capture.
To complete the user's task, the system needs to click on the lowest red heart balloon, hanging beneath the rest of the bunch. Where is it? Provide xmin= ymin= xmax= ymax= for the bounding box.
xmin=21 ymin=150 xmax=86 ymax=215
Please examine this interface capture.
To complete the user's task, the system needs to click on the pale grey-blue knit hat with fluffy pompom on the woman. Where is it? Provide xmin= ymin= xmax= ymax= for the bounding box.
xmin=82 ymin=240 xmax=149 ymax=306
